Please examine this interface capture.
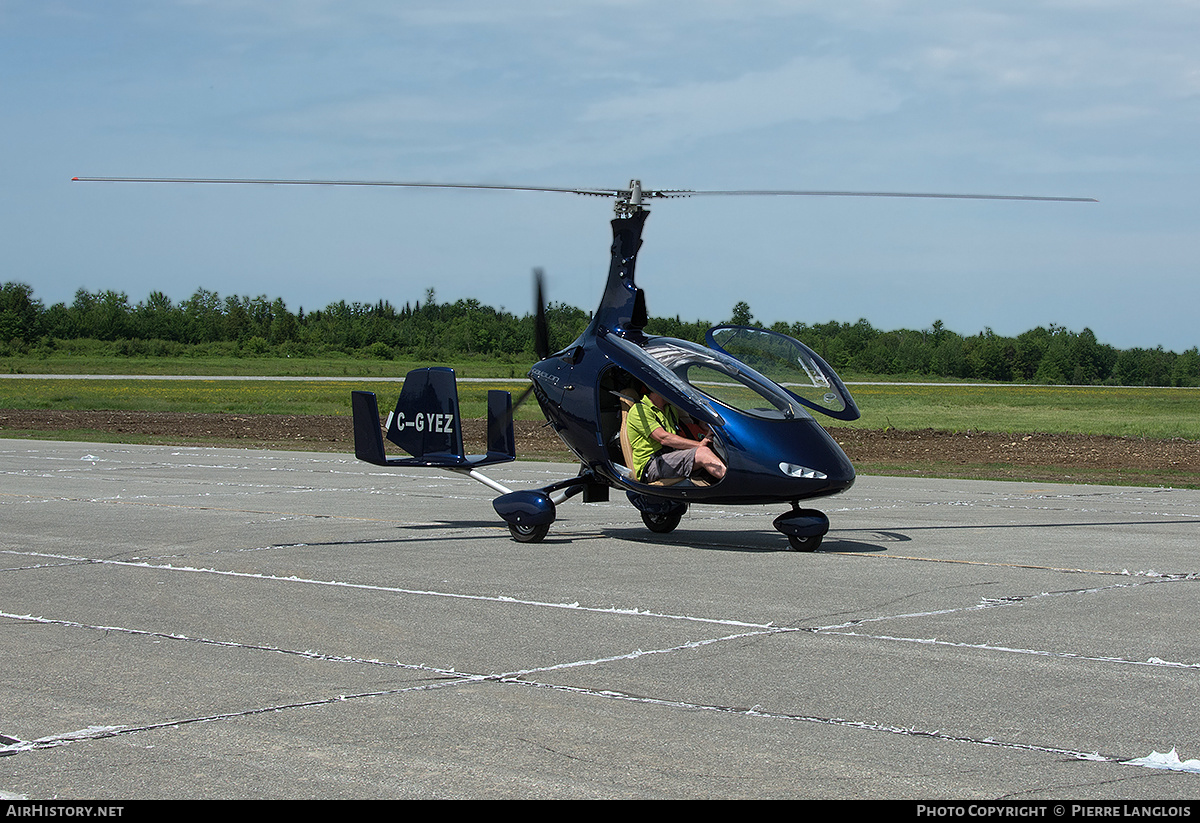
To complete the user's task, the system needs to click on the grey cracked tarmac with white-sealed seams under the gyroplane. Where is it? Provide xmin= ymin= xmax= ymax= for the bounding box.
xmin=0 ymin=440 xmax=1200 ymax=800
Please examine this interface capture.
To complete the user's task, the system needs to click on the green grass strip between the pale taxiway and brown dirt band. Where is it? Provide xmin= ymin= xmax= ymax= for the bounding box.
xmin=0 ymin=367 xmax=1200 ymax=440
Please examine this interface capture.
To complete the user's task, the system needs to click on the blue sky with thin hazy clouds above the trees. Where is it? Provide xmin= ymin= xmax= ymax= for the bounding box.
xmin=0 ymin=0 xmax=1200 ymax=352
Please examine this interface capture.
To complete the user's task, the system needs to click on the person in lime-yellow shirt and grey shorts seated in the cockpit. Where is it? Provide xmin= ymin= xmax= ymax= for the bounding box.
xmin=625 ymin=391 xmax=725 ymax=483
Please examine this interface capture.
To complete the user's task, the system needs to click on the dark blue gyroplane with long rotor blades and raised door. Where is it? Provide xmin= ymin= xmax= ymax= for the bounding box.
xmin=74 ymin=178 xmax=1094 ymax=552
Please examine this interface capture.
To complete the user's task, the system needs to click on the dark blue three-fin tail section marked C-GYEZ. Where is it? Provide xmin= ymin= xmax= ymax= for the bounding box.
xmin=352 ymin=367 xmax=516 ymax=468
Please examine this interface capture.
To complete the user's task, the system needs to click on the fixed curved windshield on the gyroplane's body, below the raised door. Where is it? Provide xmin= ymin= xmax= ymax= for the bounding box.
xmin=646 ymin=337 xmax=809 ymax=419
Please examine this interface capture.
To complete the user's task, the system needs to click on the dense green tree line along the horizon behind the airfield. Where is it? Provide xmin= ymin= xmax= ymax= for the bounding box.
xmin=0 ymin=282 xmax=1200 ymax=386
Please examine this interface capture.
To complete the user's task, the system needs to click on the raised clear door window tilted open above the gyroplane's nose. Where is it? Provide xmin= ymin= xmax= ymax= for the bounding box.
xmin=708 ymin=326 xmax=859 ymax=420
